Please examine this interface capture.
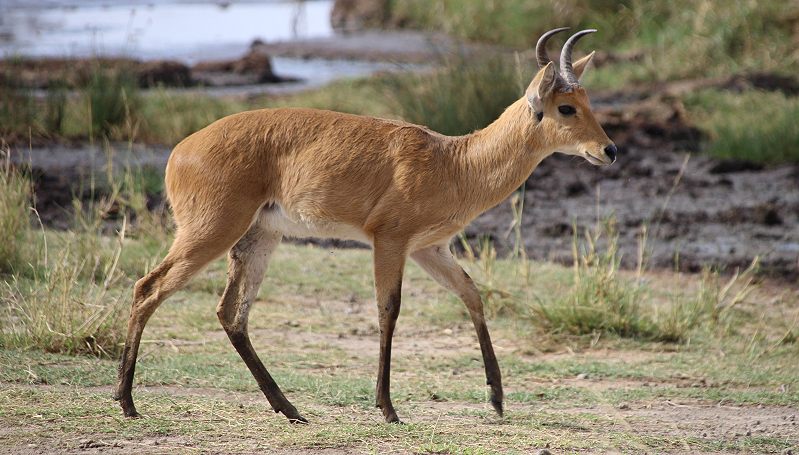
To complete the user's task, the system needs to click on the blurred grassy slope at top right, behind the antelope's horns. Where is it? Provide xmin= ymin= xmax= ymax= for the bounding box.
xmin=389 ymin=0 xmax=797 ymax=81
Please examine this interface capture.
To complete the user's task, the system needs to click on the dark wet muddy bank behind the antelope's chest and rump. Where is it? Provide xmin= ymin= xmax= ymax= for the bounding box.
xmin=7 ymin=137 xmax=799 ymax=280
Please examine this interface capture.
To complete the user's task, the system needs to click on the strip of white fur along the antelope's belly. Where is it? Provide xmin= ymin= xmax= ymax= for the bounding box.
xmin=261 ymin=205 xmax=372 ymax=244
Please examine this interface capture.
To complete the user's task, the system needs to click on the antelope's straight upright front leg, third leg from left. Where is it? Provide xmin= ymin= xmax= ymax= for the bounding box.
xmin=374 ymin=239 xmax=405 ymax=423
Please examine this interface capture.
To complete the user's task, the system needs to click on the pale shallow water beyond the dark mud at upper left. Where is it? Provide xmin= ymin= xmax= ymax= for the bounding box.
xmin=0 ymin=0 xmax=392 ymax=93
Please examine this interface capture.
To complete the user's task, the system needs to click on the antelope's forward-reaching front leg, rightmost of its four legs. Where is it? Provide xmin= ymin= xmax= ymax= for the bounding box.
xmin=411 ymin=245 xmax=503 ymax=417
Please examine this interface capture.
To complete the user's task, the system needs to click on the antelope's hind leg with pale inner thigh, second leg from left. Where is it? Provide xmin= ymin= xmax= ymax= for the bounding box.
xmin=216 ymin=224 xmax=308 ymax=423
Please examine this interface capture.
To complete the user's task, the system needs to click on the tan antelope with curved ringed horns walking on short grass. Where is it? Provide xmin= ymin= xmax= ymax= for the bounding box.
xmin=115 ymin=28 xmax=616 ymax=422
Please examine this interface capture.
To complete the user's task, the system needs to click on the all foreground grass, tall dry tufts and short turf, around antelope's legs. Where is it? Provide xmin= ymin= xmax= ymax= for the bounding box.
xmin=0 ymin=170 xmax=799 ymax=453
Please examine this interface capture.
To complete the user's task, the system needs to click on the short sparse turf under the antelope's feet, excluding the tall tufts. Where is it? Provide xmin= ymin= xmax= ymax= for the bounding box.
xmin=0 ymin=239 xmax=799 ymax=453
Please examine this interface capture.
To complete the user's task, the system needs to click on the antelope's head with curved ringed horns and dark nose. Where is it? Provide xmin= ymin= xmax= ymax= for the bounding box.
xmin=526 ymin=27 xmax=617 ymax=165
